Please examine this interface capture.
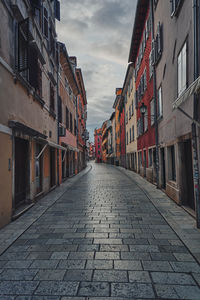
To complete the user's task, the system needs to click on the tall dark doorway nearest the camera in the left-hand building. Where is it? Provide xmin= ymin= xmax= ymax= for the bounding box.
xmin=14 ymin=138 xmax=29 ymax=208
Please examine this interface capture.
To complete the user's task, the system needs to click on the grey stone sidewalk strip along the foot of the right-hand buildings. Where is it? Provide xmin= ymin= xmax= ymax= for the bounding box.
xmin=113 ymin=166 xmax=200 ymax=263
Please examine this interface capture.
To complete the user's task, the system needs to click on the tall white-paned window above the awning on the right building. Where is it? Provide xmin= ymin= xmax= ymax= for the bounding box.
xmin=178 ymin=42 xmax=187 ymax=96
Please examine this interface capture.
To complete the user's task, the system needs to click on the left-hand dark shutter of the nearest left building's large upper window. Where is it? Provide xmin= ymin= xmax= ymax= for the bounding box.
xmin=18 ymin=18 xmax=29 ymax=72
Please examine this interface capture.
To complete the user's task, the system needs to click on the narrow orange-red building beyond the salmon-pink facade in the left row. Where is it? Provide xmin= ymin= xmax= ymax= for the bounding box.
xmin=76 ymin=68 xmax=87 ymax=171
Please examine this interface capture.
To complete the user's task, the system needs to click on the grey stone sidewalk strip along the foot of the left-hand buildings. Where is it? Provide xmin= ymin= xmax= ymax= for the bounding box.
xmin=0 ymin=164 xmax=92 ymax=255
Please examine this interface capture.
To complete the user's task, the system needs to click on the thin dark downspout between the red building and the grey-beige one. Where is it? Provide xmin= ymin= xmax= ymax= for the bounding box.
xmin=150 ymin=0 xmax=159 ymax=188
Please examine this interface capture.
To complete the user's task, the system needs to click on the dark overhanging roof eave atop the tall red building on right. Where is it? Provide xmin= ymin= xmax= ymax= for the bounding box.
xmin=128 ymin=0 xmax=150 ymax=63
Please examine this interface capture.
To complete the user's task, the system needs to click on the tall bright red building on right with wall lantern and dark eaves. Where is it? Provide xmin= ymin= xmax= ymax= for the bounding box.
xmin=129 ymin=0 xmax=156 ymax=181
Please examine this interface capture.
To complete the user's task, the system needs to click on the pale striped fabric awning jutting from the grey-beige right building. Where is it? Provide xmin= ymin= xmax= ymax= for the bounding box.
xmin=173 ymin=76 xmax=200 ymax=109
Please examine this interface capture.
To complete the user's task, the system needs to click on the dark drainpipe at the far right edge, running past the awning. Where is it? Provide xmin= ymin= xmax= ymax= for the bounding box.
xmin=192 ymin=0 xmax=200 ymax=228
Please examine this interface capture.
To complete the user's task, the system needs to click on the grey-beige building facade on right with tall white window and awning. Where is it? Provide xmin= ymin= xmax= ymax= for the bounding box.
xmin=153 ymin=1 xmax=200 ymax=210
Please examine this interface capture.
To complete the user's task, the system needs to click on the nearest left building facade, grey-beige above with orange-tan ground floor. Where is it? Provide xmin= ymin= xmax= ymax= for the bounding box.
xmin=0 ymin=0 xmax=60 ymax=226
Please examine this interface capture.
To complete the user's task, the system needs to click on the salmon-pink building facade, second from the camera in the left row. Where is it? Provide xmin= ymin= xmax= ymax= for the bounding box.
xmin=58 ymin=43 xmax=79 ymax=180
